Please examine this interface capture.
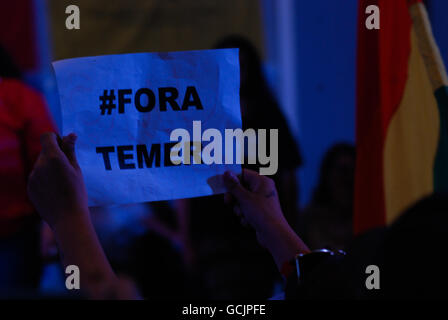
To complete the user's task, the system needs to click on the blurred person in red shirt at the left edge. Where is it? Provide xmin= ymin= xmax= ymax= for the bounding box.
xmin=0 ymin=46 xmax=55 ymax=292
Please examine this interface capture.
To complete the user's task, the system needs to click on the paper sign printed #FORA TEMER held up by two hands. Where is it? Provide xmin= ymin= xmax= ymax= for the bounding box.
xmin=53 ymin=49 xmax=241 ymax=206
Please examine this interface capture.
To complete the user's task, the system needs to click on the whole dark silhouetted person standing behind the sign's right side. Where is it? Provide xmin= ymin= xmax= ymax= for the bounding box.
xmin=180 ymin=36 xmax=302 ymax=300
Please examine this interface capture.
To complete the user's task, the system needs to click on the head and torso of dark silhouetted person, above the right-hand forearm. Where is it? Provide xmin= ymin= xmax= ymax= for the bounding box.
xmin=216 ymin=35 xmax=302 ymax=228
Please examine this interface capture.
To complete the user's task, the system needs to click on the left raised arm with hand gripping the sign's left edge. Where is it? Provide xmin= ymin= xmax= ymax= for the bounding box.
xmin=28 ymin=133 xmax=126 ymax=299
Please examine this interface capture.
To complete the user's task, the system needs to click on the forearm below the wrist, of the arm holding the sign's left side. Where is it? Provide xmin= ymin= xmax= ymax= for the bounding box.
xmin=52 ymin=209 xmax=116 ymax=299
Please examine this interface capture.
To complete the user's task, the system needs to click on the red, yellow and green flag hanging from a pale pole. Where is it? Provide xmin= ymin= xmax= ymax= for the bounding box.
xmin=354 ymin=0 xmax=448 ymax=233
